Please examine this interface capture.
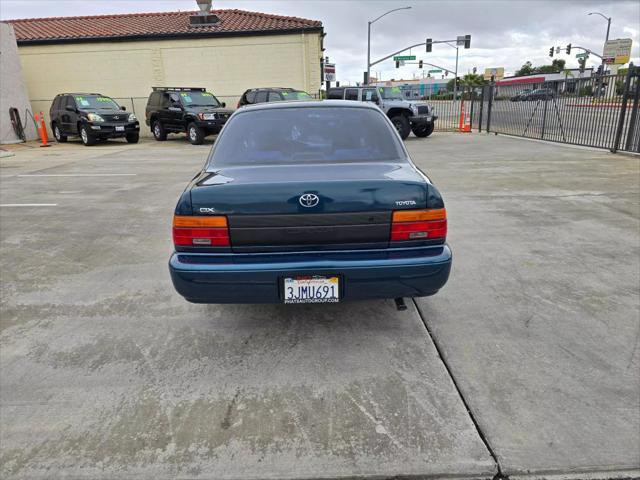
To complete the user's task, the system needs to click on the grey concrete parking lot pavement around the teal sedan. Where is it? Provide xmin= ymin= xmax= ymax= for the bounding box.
xmin=0 ymin=133 xmax=640 ymax=479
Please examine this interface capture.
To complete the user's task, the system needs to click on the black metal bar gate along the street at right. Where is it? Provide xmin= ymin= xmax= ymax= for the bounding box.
xmin=471 ymin=64 xmax=640 ymax=152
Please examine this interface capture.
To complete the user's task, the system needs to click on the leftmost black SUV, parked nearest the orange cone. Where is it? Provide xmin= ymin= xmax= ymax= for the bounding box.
xmin=49 ymin=93 xmax=140 ymax=146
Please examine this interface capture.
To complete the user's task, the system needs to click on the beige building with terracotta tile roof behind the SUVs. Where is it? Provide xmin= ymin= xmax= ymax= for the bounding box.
xmin=8 ymin=10 xmax=324 ymax=134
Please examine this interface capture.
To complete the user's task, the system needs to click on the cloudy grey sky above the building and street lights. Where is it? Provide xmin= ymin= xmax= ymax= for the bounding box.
xmin=0 ymin=0 xmax=640 ymax=82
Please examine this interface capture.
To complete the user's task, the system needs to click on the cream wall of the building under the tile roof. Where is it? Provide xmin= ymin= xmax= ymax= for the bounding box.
xmin=19 ymin=32 xmax=322 ymax=134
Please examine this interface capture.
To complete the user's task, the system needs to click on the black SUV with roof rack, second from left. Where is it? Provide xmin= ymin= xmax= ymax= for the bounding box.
xmin=145 ymin=87 xmax=233 ymax=145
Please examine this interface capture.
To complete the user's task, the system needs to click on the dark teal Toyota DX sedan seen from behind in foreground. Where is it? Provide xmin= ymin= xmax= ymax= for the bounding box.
xmin=169 ymin=100 xmax=451 ymax=308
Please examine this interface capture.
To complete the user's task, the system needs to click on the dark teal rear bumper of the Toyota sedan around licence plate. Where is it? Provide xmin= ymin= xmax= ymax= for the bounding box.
xmin=169 ymin=245 xmax=452 ymax=303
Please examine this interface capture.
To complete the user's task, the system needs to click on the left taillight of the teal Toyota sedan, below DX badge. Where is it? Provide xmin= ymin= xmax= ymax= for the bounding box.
xmin=173 ymin=215 xmax=230 ymax=247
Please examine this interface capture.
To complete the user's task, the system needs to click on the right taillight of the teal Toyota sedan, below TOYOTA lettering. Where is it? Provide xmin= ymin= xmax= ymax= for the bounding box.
xmin=391 ymin=208 xmax=447 ymax=242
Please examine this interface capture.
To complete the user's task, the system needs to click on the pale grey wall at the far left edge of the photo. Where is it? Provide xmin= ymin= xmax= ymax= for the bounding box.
xmin=0 ymin=23 xmax=38 ymax=143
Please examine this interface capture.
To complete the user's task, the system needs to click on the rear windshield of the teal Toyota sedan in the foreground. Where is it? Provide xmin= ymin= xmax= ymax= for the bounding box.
xmin=207 ymin=107 xmax=406 ymax=171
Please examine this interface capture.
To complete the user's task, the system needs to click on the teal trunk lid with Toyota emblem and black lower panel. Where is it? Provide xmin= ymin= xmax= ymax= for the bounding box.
xmin=191 ymin=163 xmax=426 ymax=252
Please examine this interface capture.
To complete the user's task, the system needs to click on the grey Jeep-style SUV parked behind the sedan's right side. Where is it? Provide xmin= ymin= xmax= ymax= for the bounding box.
xmin=327 ymin=87 xmax=438 ymax=140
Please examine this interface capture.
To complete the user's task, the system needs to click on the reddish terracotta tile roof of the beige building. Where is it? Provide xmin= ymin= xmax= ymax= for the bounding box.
xmin=6 ymin=9 xmax=322 ymax=44
